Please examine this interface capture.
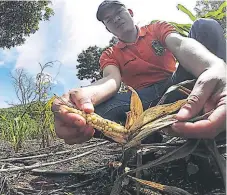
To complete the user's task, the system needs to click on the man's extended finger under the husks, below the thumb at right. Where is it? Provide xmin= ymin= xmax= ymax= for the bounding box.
xmin=172 ymin=105 xmax=226 ymax=138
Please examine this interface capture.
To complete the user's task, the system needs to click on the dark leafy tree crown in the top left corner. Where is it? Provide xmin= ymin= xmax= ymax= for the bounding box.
xmin=0 ymin=0 xmax=54 ymax=49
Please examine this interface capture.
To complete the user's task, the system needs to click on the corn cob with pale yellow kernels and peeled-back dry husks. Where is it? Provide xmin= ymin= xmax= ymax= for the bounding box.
xmin=55 ymin=82 xmax=187 ymax=147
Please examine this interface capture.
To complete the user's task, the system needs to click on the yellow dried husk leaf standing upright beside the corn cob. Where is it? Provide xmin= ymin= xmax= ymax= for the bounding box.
xmin=125 ymin=86 xmax=143 ymax=129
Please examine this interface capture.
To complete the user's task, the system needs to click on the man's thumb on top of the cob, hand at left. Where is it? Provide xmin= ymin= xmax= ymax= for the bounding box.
xmin=70 ymin=91 xmax=94 ymax=113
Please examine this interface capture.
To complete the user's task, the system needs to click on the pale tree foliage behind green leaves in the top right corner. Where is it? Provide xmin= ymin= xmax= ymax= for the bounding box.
xmin=194 ymin=0 xmax=226 ymax=34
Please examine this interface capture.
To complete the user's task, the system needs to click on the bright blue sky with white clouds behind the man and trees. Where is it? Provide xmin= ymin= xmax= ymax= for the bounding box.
xmin=0 ymin=0 xmax=196 ymax=108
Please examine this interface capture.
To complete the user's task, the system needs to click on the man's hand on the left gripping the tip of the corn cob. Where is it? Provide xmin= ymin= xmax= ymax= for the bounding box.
xmin=52 ymin=88 xmax=94 ymax=145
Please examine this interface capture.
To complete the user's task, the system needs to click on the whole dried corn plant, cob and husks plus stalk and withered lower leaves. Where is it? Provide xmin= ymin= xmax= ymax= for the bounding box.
xmin=55 ymin=80 xmax=226 ymax=195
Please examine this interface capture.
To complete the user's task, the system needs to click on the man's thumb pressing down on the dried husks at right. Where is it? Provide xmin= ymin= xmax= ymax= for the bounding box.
xmin=176 ymin=71 xmax=217 ymax=121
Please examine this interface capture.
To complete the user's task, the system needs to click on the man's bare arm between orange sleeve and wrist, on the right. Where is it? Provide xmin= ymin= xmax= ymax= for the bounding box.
xmin=167 ymin=36 xmax=225 ymax=77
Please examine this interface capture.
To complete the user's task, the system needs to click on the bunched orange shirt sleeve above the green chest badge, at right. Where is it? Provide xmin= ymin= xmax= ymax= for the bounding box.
xmin=152 ymin=21 xmax=177 ymax=46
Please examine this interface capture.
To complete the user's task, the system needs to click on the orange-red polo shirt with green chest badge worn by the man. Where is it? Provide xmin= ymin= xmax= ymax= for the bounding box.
xmin=100 ymin=22 xmax=176 ymax=89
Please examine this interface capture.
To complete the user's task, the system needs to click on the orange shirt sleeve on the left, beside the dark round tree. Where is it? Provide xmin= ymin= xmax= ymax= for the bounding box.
xmin=99 ymin=47 xmax=119 ymax=70
